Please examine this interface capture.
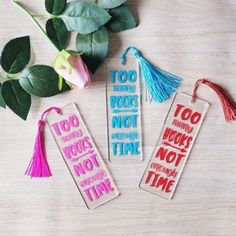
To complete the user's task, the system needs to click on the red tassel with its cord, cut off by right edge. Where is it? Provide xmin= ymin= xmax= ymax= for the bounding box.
xmin=192 ymin=79 xmax=236 ymax=122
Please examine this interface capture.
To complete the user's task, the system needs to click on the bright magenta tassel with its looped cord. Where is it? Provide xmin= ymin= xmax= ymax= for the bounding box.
xmin=25 ymin=107 xmax=61 ymax=178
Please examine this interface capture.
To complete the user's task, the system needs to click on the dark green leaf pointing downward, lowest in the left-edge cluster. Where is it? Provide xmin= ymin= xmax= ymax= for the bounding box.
xmin=2 ymin=79 xmax=31 ymax=120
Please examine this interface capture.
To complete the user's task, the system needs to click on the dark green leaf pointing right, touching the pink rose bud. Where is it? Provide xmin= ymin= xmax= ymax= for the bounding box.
xmin=20 ymin=65 xmax=70 ymax=97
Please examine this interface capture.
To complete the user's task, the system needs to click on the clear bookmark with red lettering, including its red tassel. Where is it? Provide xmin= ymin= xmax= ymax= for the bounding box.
xmin=140 ymin=79 xmax=236 ymax=199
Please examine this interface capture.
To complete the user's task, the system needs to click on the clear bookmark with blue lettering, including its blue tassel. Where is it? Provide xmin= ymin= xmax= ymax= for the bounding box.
xmin=106 ymin=47 xmax=181 ymax=161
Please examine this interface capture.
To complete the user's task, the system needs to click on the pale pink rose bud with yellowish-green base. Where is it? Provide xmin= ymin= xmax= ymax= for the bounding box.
xmin=53 ymin=50 xmax=91 ymax=89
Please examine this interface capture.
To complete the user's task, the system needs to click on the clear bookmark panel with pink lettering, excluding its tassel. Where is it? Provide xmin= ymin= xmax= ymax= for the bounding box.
xmin=46 ymin=104 xmax=119 ymax=209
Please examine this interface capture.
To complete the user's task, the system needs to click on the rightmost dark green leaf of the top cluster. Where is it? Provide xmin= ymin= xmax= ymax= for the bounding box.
xmin=106 ymin=6 xmax=137 ymax=32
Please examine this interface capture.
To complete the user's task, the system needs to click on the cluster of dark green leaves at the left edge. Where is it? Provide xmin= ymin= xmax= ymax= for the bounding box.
xmin=0 ymin=36 xmax=70 ymax=120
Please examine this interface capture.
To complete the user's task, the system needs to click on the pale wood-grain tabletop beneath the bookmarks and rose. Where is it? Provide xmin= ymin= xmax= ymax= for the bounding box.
xmin=0 ymin=0 xmax=236 ymax=236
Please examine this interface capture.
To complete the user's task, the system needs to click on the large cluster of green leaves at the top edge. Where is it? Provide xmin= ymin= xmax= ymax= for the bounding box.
xmin=45 ymin=0 xmax=137 ymax=73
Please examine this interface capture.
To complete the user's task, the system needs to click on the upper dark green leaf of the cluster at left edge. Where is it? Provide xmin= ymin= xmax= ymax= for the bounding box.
xmin=1 ymin=36 xmax=30 ymax=74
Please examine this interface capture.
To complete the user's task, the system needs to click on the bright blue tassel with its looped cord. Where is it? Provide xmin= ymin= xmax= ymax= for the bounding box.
xmin=120 ymin=47 xmax=181 ymax=103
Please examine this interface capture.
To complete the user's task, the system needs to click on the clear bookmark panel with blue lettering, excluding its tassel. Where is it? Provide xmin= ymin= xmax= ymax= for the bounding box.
xmin=106 ymin=58 xmax=142 ymax=161
